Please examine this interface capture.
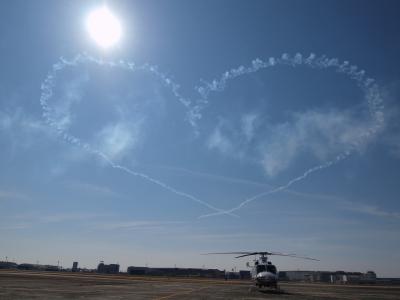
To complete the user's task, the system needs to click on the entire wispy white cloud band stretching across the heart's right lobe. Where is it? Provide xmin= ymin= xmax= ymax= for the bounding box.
xmin=206 ymin=109 xmax=369 ymax=177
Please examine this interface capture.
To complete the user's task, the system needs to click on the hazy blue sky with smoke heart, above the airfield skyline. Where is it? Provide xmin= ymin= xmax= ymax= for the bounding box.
xmin=0 ymin=0 xmax=400 ymax=277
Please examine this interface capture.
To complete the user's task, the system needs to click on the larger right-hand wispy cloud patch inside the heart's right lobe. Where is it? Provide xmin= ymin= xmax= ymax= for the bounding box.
xmin=260 ymin=110 xmax=368 ymax=176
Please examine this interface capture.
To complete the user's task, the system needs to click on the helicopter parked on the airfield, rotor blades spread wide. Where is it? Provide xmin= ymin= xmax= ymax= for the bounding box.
xmin=204 ymin=251 xmax=319 ymax=289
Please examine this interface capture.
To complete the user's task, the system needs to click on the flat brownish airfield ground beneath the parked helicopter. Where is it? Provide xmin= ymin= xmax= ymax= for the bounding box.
xmin=0 ymin=270 xmax=400 ymax=300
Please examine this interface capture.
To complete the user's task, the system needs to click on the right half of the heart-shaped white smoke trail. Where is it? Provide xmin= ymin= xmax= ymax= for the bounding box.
xmin=196 ymin=53 xmax=384 ymax=218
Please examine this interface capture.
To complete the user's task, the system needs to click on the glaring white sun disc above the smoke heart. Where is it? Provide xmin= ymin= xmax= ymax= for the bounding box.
xmin=86 ymin=6 xmax=122 ymax=48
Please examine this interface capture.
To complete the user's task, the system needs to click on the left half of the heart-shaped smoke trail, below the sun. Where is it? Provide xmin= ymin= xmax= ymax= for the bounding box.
xmin=40 ymin=54 xmax=236 ymax=216
